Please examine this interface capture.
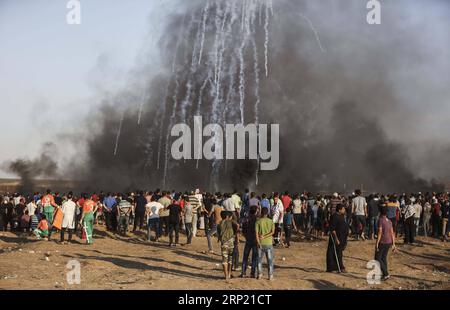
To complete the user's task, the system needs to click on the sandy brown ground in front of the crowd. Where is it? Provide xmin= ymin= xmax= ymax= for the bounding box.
xmin=0 ymin=227 xmax=450 ymax=290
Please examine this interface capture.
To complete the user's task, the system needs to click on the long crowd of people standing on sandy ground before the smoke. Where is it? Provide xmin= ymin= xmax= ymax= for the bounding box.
xmin=0 ymin=189 xmax=450 ymax=279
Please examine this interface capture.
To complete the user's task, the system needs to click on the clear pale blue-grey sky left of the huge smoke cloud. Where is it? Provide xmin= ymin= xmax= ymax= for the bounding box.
xmin=0 ymin=0 xmax=173 ymax=177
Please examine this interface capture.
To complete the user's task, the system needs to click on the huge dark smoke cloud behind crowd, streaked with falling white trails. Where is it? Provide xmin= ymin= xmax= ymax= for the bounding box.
xmin=62 ymin=0 xmax=450 ymax=191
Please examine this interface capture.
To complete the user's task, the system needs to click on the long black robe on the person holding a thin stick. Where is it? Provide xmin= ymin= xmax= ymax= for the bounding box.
xmin=327 ymin=213 xmax=349 ymax=272
